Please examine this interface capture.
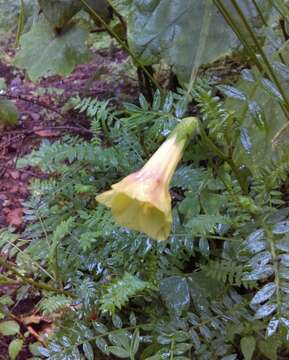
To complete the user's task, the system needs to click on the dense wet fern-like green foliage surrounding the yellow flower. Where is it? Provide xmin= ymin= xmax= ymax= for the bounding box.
xmin=0 ymin=1 xmax=289 ymax=360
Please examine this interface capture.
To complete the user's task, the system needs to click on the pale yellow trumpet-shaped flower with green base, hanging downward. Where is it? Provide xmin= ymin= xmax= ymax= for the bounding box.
xmin=96 ymin=117 xmax=198 ymax=240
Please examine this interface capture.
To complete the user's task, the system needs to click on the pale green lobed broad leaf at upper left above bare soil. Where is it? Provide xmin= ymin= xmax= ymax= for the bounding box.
xmin=15 ymin=18 xmax=88 ymax=81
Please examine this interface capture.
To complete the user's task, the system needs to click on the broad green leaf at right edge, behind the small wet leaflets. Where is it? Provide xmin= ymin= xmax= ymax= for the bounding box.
xmin=231 ymin=72 xmax=289 ymax=174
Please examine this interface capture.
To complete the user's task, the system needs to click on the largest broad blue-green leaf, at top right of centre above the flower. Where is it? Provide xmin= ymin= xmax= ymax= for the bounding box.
xmin=122 ymin=0 xmax=271 ymax=82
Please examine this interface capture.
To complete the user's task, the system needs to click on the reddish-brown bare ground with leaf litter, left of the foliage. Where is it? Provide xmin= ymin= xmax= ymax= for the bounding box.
xmin=0 ymin=38 xmax=137 ymax=360
